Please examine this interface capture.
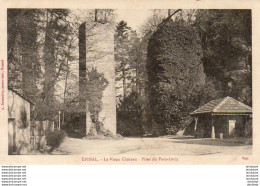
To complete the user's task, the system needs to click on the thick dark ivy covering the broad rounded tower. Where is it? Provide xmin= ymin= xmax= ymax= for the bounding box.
xmin=147 ymin=20 xmax=214 ymax=134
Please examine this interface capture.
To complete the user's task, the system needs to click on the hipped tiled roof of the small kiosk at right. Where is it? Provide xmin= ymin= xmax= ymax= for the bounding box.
xmin=191 ymin=96 xmax=252 ymax=115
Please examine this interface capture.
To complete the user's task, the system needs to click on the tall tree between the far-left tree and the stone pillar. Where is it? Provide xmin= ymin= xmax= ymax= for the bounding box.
xmin=39 ymin=9 xmax=73 ymax=119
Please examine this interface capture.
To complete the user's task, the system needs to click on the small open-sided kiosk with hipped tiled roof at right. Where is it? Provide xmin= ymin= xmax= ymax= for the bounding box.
xmin=191 ymin=96 xmax=252 ymax=139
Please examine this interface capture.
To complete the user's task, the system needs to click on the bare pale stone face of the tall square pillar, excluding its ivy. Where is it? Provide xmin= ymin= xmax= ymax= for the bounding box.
xmin=86 ymin=23 xmax=116 ymax=134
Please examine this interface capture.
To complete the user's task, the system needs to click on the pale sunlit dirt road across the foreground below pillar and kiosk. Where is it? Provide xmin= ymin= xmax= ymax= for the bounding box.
xmin=61 ymin=136 xmax=252 ymax=155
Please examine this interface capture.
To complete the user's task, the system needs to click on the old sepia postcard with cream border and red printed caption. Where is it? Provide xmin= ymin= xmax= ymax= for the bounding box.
xmin=0 ymin=0 xmax=260 ymax=164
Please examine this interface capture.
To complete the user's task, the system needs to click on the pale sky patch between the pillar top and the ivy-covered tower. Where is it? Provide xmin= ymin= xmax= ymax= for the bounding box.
xmin=115 ymin=9 xmax=152 ymax=31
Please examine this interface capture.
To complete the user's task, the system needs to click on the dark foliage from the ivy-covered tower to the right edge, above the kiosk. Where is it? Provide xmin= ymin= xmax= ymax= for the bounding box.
xmin=147 ymin=10 xmax=252 ymax=134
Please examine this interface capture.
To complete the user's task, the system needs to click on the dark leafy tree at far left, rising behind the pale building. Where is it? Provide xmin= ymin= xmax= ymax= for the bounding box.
xmin=7 ymin=9 xmax=41 ymax=101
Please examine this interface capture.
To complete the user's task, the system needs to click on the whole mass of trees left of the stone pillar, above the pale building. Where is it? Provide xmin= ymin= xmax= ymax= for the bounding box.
xmin=7 ymin=9 xmax=75 ymax=120
